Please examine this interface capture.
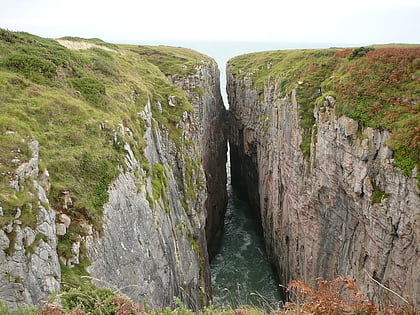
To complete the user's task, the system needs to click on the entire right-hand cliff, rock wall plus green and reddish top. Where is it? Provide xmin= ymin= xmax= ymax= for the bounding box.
xmin=228 ymin=47 xmax=420 ymax=307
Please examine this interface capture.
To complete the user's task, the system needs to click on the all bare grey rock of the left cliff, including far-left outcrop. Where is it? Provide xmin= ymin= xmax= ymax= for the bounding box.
xmin=0 ymin=56 xmax=227 ymax=310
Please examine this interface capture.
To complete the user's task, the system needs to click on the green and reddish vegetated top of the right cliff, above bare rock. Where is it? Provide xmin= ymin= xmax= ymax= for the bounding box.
xmin=228 ymin=45 xmax=420 ymax=180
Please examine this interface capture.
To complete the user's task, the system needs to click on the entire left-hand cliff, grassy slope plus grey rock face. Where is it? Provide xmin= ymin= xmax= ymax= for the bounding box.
xmin=0 ymin=30 xmax=226 ymax=309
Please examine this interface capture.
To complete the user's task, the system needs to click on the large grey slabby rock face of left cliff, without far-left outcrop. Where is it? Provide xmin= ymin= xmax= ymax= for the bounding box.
xmin=87 ymin=59 xmax=226 ymax=309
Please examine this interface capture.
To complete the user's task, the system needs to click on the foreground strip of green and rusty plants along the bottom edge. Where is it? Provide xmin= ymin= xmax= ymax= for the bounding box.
xmin=0 ymin=277 xmax=417 ymax=315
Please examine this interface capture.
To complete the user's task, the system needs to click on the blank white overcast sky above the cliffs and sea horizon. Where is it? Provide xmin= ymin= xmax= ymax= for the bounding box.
xmin=0 ymin=0 xmax=420 ymax=44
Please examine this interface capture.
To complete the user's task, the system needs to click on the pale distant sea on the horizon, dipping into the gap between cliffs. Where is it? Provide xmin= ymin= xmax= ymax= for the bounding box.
xmin=111 ymin=40 xmax=363 ymax=108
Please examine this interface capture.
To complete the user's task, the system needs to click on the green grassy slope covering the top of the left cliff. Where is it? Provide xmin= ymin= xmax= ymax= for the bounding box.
xmin=0 ymin=29 xmax=208 ymax=230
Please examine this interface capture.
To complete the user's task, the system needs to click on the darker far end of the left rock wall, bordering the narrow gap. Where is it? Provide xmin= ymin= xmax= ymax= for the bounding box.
xmin=170 ymin=65 xmax=227 ymax=260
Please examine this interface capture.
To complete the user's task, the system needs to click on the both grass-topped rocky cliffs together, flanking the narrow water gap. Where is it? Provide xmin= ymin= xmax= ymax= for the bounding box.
xmin=0 ymin=29 xmax=420 ymax=311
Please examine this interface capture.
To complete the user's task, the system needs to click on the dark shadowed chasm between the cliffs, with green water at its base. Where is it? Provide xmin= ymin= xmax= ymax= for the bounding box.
xmin=210 ymin=88 xmax=282 ymax=309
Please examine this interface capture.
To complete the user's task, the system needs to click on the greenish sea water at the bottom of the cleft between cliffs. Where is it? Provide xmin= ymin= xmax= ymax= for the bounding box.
xmin=210 ymin=160 xmax=281 ymax=308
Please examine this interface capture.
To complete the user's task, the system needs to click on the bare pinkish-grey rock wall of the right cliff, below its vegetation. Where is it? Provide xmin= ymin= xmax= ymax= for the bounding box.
xmin=228 ymin=71 xmax=420 ymax=307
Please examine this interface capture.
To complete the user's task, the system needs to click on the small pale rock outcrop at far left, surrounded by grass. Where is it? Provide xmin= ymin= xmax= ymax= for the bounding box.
xmin=0 ymin=140 xmax=61 ymax=308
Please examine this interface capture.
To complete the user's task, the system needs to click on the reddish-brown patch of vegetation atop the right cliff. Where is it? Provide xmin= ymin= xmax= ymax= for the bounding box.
xmin=333 ymin=47 xmax=420 ymax=174
